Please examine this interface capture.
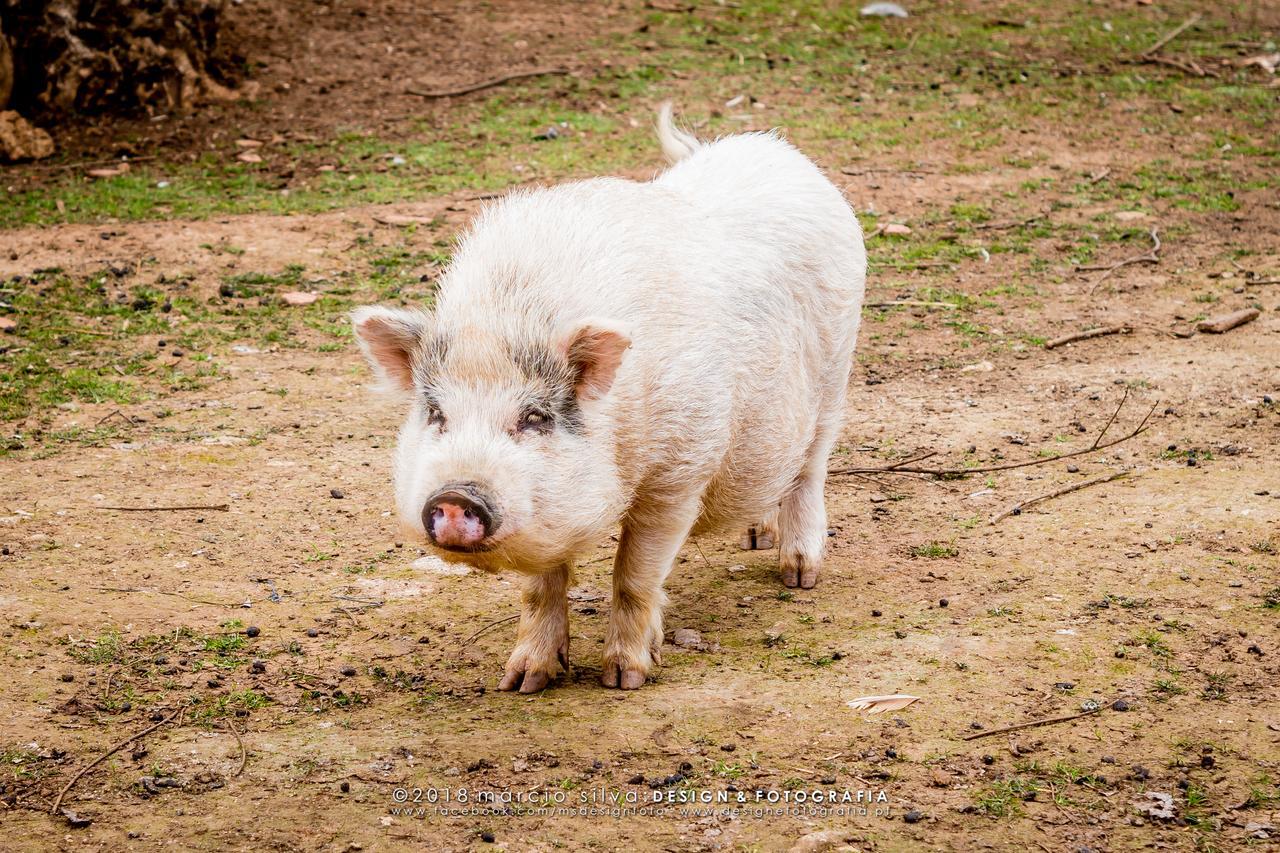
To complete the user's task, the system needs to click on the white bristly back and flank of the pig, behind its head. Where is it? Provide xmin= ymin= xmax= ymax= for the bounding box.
xmin=438 ymin=134 xmax=865 ymax=528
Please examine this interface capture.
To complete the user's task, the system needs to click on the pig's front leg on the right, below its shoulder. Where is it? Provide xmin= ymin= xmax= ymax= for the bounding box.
xmin=600 ymin=498 xmax=699 ymax=690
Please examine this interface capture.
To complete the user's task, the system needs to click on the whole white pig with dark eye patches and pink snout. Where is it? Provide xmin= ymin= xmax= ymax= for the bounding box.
xmin=352 ymin=105 xmax=867 ymax=693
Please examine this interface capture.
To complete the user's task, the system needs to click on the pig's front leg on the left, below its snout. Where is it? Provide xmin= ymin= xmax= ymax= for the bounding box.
xmin=498 ymin=566 xmax=570 ymax=693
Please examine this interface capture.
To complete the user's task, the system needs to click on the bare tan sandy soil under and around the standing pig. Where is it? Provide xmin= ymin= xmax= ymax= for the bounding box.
xmin=0 ymin=1 xmax=1280 ymax=850
